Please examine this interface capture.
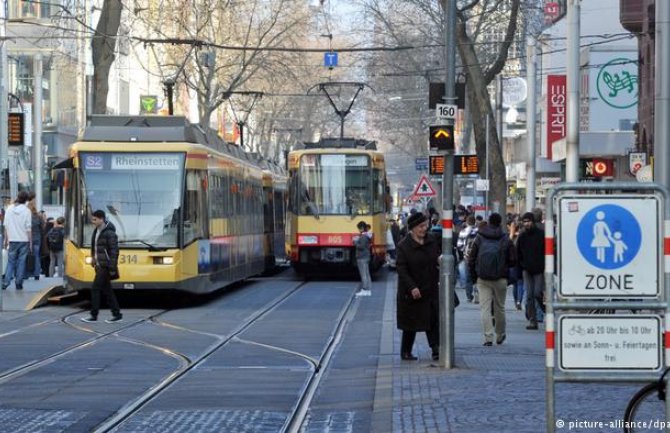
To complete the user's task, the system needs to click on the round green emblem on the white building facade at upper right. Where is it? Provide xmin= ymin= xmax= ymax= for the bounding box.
xmin=596 ymin=58 xmax=638 ymax=109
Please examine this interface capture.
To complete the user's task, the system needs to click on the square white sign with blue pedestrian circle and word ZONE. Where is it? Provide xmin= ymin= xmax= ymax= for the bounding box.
xmin=557 ymin=195 xmax=663 ymax=299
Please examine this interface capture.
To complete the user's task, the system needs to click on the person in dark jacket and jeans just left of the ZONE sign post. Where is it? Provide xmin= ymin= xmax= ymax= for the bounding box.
xmin=516 ymin=212 xmax=544 ymax=329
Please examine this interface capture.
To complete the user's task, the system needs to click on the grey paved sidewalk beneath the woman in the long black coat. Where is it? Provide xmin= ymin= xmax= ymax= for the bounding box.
xmin=384 ymin=277 xmax=652 ymax=433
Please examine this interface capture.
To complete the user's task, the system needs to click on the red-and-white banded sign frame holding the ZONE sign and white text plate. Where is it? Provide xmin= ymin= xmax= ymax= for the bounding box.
xmin=544 ymin=182 xmax=670 ymax=433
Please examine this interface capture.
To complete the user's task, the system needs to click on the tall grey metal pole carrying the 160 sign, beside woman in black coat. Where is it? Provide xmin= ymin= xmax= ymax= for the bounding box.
xmin=440 ymin=0 xmax=456 ymax=369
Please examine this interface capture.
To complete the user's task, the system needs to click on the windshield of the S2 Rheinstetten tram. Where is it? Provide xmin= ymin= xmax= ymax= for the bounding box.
xmin=80 ymin=152 xmax=184 ymax=248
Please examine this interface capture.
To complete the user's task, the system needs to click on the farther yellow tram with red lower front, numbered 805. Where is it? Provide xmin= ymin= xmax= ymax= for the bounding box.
xmin=285 ymin=139 xmax=390 ymax=273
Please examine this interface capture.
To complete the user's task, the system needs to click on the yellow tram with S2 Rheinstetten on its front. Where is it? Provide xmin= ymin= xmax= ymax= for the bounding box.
xmin=56 ymin=116 xmax=287 ymax=293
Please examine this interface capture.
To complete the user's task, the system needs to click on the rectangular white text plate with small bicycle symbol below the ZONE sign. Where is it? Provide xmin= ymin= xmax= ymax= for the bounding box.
xmin=557 ymin=314 xmax=663 ymax=371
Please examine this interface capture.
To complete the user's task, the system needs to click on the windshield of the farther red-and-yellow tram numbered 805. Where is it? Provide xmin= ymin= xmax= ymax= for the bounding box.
xmin=297 ymin=154 xmax=373 ymax=216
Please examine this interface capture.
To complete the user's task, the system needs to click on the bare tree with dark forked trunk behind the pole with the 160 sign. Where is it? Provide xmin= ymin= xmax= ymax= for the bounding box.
xmin=362 ymin=0 xmax=537 ymax=210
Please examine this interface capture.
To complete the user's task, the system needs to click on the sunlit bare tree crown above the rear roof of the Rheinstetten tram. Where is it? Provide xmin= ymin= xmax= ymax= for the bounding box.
xmin=143 ymin=0 xmax=309 ymax=127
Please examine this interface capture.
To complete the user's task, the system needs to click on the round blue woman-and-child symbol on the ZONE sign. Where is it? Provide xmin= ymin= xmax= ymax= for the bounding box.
xmin=577 ymin=204 xmax=642 ymax=269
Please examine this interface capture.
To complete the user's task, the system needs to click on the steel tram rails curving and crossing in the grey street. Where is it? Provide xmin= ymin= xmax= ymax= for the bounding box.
xmin=0 ymin=281 xmax=358 ymax=433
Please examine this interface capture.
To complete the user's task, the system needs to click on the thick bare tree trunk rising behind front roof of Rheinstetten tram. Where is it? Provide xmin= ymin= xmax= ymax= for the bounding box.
xmin=91 ymin=0 xmax=122 ymax=114
